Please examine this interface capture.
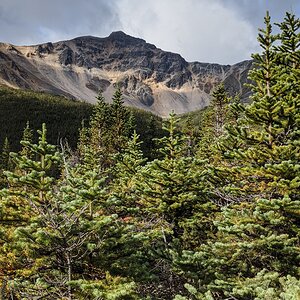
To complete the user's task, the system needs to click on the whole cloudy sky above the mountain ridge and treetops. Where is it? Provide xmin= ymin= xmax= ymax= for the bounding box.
xmin=0 ymin=0 xmax=300 ymax=64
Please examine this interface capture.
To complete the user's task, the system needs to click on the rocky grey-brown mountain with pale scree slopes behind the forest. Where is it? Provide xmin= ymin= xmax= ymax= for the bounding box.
xmin=0 ymin=31 xmax=252 ymax=116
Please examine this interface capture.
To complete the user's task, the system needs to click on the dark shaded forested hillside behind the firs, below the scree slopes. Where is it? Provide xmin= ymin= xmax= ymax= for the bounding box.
xmin=0 ymin=86 xmax=162 ymax=155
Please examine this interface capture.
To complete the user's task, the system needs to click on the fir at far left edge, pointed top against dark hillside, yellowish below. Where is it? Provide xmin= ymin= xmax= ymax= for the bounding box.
xmin=1 ymin=125 xmax=59 ymax=294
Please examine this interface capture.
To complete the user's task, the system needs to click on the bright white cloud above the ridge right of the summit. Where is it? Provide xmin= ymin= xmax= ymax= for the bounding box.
xmin=118 ymin=0 xmax=256 ymax=63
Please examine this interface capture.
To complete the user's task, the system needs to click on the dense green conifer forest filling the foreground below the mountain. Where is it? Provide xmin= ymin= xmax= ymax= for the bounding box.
xmin=0 ymin=13 xmax=300 ymax=300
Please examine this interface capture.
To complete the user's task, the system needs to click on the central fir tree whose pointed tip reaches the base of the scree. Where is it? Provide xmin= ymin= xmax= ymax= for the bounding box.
xmin=137 ymin=114 xmax=216 ymax=299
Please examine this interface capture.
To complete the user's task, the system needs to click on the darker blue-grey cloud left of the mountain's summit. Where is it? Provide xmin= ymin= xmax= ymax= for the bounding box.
xmin=0 ymin=0 xmax=119 ymax=44
